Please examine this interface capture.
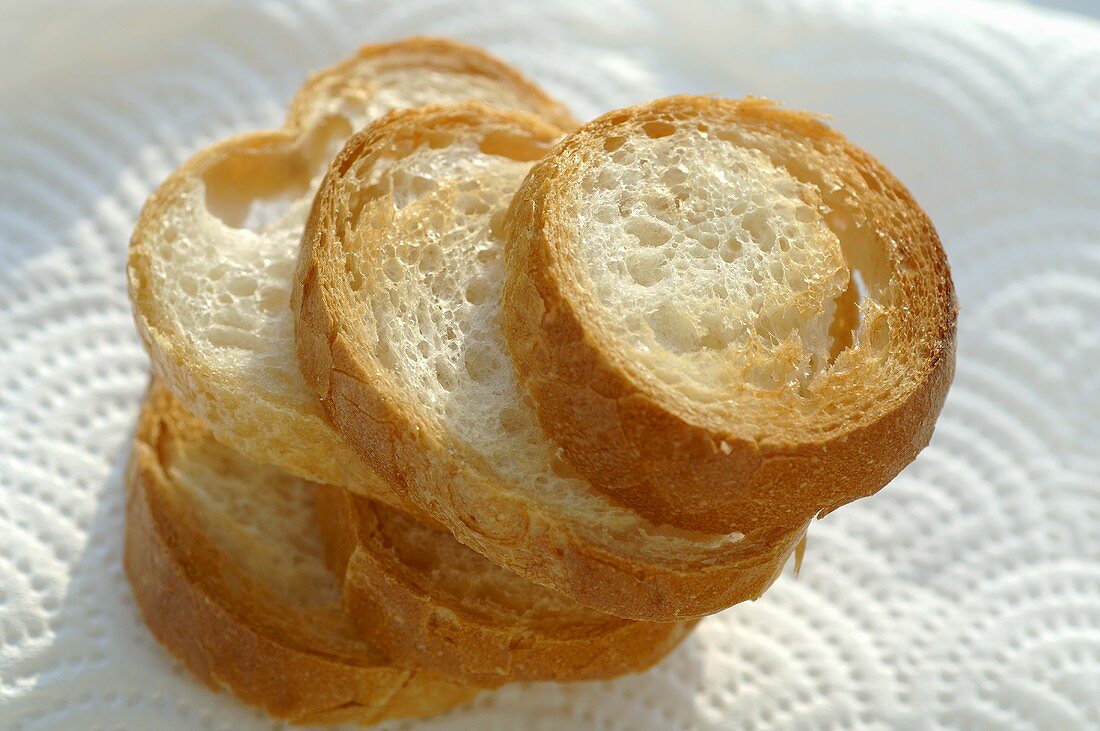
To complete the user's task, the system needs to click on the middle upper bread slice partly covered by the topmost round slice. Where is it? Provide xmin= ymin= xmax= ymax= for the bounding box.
xmin=293 ymin=104 xmax=804 ymax=621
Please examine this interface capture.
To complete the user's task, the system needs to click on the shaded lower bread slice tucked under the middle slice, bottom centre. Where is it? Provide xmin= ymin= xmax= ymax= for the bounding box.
xmin=317 ymin=486 xmax=695 ymax=687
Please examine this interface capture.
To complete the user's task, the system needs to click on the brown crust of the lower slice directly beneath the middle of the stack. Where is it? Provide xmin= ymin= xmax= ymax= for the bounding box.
xmin=317 ymin=486 xmax=696 ymax=688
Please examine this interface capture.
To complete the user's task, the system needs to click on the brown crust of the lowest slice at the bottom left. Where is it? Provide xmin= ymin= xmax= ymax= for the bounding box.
xmin=124 ymin=386 xmax=476 ymax=724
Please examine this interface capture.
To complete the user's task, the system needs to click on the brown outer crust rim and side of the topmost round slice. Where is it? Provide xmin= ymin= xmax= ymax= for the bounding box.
xmin=504 ymin=96 xmax=958 ymax=535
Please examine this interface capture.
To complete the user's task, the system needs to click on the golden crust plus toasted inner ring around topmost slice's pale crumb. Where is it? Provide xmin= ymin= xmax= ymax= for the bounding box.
xmin=504 ymin=97 xmax=957 ymax=536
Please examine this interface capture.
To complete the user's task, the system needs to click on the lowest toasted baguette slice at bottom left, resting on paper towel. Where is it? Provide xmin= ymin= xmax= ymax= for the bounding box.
xmin=125 ymin=386 xmax=476 ymax=723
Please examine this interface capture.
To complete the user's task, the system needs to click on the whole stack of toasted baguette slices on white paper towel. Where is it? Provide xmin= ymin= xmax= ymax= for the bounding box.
xmin=125 ymin=38 xmax=956 ymax=723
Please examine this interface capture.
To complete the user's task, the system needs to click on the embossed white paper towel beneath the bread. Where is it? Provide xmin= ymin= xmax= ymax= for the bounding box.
xmin=0 ymin=0 xmax=1100 ymax=730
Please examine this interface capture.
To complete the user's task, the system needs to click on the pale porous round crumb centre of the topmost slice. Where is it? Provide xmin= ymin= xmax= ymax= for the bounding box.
xmin=571 ymin=125 xmax=849 ymax=391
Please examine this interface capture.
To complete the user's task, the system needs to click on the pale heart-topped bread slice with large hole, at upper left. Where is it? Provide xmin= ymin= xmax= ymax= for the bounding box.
xmin=128 ymin=38 xmax=572 ymax=501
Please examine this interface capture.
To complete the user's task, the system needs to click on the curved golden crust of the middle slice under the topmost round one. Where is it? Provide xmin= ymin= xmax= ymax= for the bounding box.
xmin=292 ymin=104 xmax=809 ymax=621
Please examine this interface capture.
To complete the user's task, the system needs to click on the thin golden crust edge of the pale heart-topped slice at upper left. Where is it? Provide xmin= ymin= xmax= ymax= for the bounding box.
xmin=128 ymin=37 xmax=575 ymax=510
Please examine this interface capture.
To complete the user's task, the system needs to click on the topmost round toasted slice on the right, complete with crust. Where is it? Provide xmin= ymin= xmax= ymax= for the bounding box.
xmin=504 ymin=97 xmax=957 ymax=535
